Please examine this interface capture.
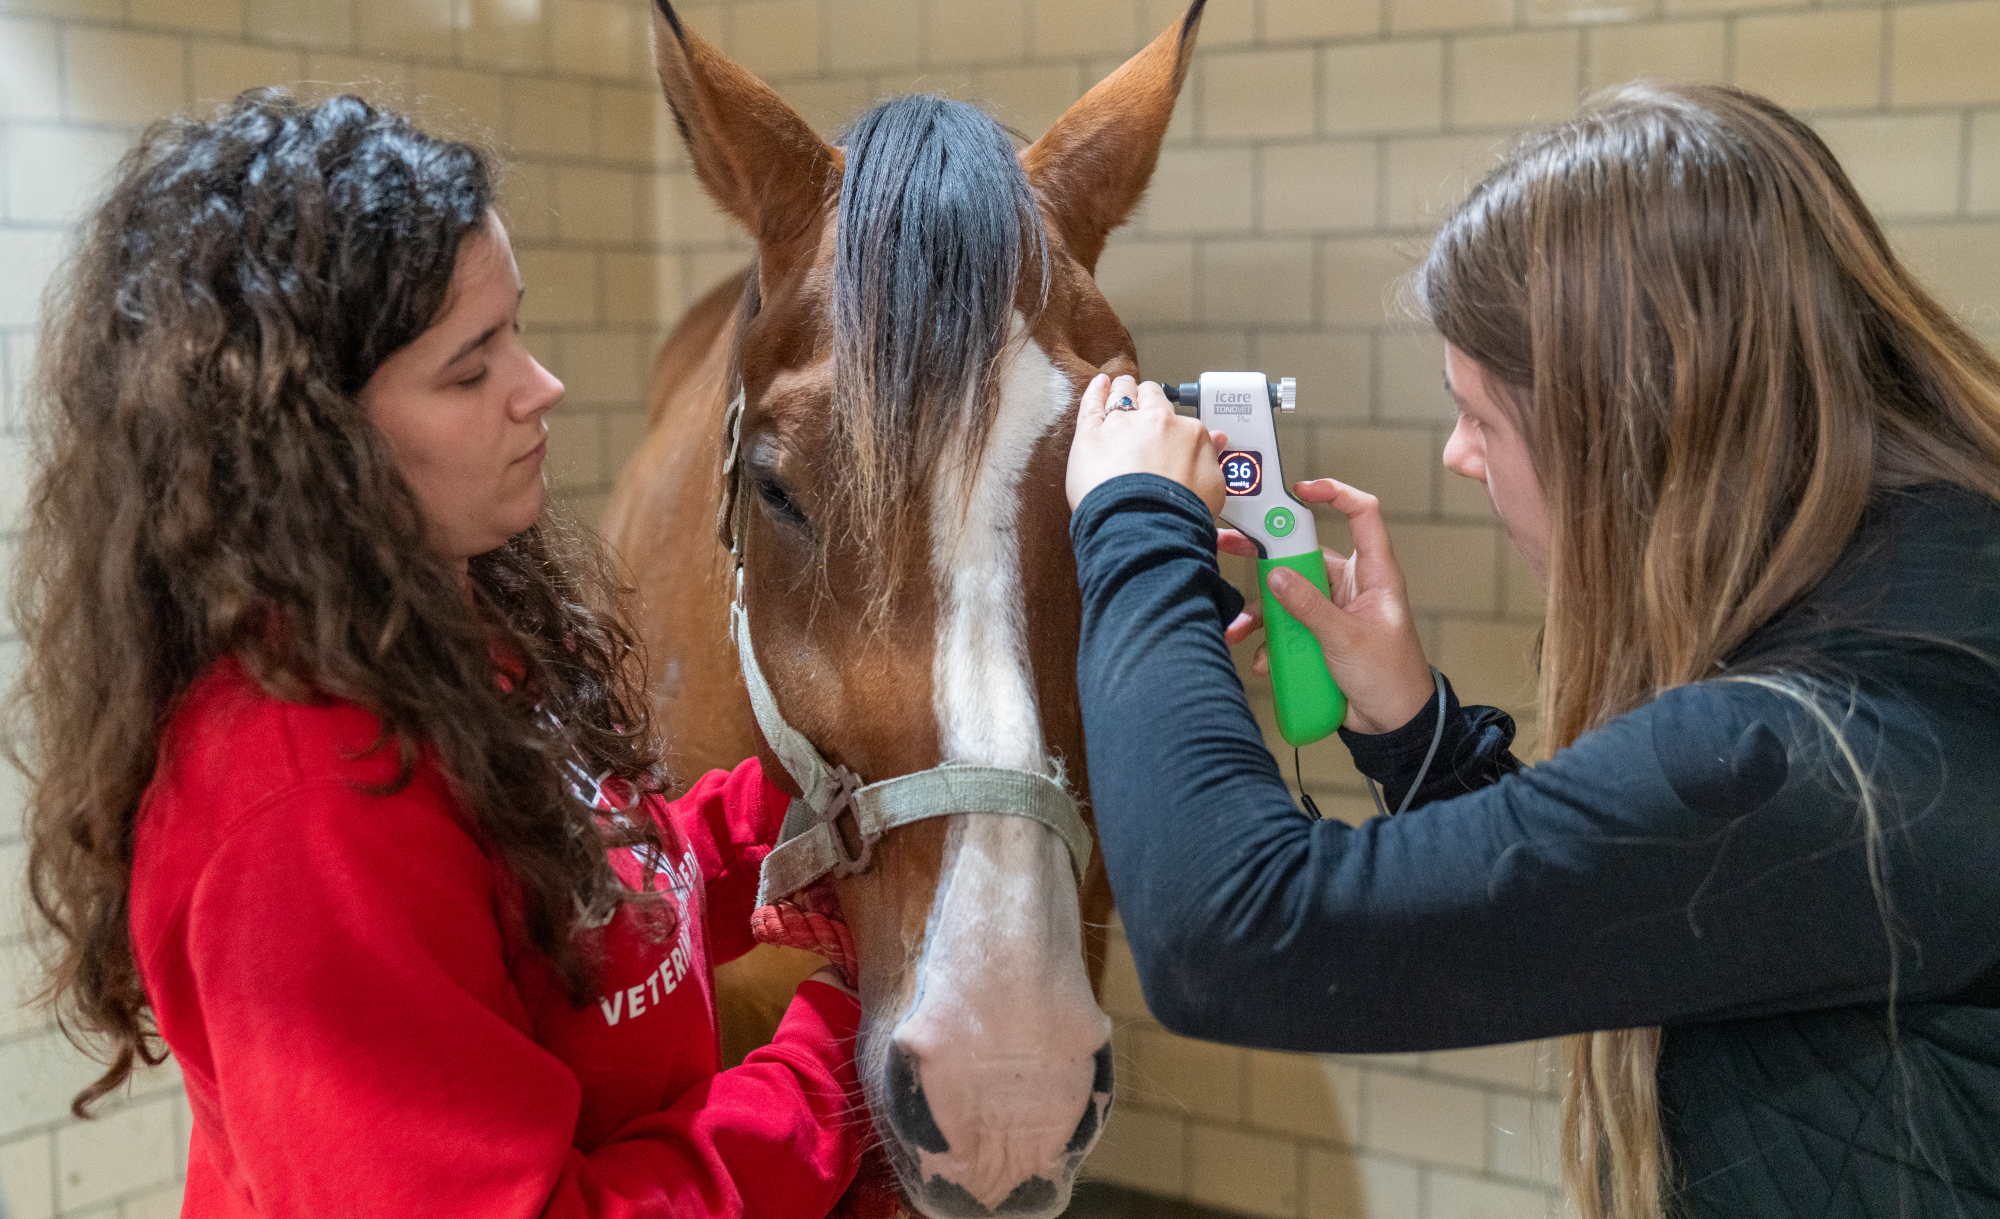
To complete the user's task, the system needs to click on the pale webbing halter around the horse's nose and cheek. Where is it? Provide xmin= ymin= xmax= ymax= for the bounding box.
xmin=718 ymin=390 xmax=1090 ymax=907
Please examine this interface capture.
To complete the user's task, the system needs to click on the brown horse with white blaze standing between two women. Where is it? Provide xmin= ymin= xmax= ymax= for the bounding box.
xmin=604 ymin=0 xmax=1206 ymax=1219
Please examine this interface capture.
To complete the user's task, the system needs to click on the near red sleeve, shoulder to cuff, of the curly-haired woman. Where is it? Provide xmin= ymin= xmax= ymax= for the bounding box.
xmin=184 ymin=767 xmax=866 ymax=1219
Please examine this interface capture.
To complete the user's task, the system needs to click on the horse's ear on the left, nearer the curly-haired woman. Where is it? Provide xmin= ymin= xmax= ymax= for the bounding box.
xmin=652 ymin=0 xmax=840 ymax=264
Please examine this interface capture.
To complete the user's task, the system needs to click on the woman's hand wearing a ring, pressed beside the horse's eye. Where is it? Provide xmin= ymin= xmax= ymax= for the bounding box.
xmin=1066 ymin=374 xmax=1222 ymax=514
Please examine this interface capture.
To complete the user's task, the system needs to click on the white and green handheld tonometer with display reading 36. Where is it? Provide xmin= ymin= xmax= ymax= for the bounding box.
xmin=1162 ymin=372 xmax=1348 ymax=747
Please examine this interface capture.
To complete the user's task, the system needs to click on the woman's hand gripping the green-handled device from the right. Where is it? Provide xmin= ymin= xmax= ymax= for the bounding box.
xmin=1216 ymin=478 xmax=1436 ymax=733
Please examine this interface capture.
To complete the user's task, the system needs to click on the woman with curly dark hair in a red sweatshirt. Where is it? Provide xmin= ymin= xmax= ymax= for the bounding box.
xmin=16 ymin=92 xmax=866 ymax=1217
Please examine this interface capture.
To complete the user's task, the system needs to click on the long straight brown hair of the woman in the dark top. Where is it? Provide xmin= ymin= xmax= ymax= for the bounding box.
xmin=1418 ymin=86 xmax=2000 ymax=1219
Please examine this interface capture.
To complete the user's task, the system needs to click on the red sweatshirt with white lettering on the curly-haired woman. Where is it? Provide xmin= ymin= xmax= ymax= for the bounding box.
xmin=132 ymin=661 xmax=868 ymax=1219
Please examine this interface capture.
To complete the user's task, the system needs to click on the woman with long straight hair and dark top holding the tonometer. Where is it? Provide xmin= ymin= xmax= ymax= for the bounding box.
xmin=1070 ymin=86 xmax=2000 ymax=1219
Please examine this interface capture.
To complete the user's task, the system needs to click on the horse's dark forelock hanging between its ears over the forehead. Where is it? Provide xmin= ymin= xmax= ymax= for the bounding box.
xmin=826 ymin=94 xmax=1046 ymax=608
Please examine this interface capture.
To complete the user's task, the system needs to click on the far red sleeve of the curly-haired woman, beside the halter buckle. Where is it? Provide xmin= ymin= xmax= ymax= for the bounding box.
xmin=654 ymin=757 xmax=792 ymax=965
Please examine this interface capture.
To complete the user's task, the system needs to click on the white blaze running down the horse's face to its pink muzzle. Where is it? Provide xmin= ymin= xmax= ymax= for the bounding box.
xmin=890 ymin=328 xmax=1112 ymax=1217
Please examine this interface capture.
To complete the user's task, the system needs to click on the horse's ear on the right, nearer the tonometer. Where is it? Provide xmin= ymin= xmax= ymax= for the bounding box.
xmin=1020 ymin=0 xmax=1206 ymax=272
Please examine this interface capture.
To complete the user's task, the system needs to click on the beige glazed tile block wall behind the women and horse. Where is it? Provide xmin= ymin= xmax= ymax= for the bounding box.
xmin=0 ymin=0 xmax=2000 ymax=1219
